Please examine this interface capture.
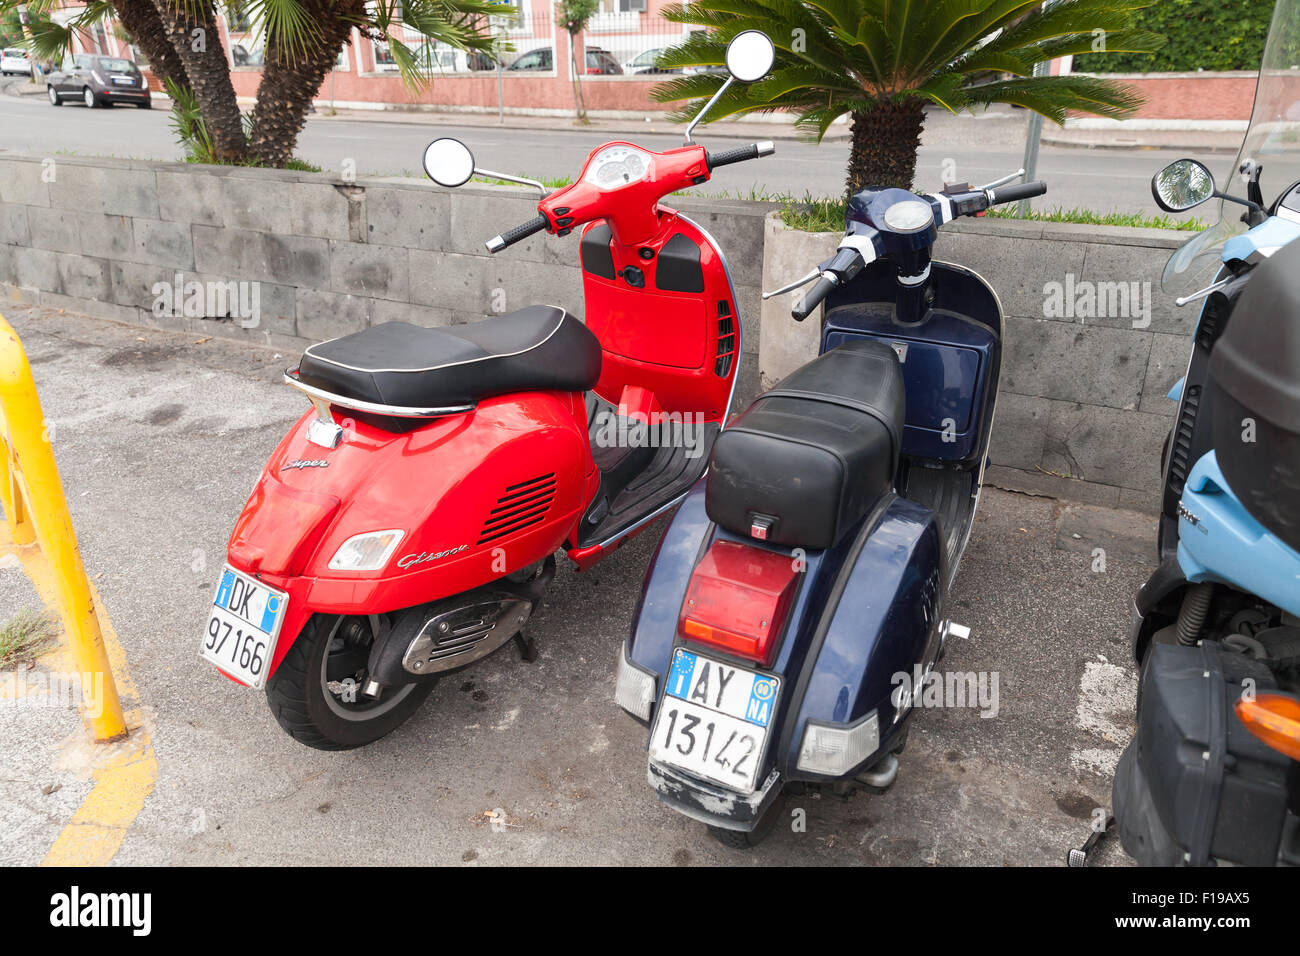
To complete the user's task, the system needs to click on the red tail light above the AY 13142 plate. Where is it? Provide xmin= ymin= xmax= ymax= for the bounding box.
xmin=677 ymin=541 xmax=800 ymax=667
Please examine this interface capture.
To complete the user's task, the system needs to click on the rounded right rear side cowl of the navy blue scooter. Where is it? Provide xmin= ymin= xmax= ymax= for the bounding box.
xmin=777 ymin=498 xmax=946 ymax=780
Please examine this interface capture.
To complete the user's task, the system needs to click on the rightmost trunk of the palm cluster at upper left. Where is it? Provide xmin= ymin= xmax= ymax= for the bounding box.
xmin=250 ymin=14 xmax=351 ymax=169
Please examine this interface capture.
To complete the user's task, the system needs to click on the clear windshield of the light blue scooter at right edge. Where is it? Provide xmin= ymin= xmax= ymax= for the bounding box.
xmin=1162 ymin=0 xmax=1300 ymax=295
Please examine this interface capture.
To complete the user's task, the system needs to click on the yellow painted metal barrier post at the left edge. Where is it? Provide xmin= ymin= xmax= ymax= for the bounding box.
xmin=0 ymin=316 xmax=126 ymax=743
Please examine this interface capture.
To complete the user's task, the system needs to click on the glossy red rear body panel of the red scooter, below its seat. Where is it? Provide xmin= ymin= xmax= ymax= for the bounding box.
xmin=228 ymin=393 xmax=593 ymax=674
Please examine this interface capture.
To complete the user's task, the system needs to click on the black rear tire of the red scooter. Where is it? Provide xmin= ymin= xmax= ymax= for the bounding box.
xmin=267 ymin=614 xmax=437 ymax=750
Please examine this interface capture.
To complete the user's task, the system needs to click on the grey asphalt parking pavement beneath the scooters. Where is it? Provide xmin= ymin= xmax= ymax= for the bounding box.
xmin=0 ymin=306 xmax=1157 ymax=865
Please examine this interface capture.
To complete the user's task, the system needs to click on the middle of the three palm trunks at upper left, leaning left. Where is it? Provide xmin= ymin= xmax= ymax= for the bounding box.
xmin=151 ymin=0 xmax=248 ymax=163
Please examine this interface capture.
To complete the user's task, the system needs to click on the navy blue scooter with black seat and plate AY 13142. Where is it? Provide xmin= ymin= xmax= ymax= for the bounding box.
xmin=616 ymin=170 xmax=1047 ymax=848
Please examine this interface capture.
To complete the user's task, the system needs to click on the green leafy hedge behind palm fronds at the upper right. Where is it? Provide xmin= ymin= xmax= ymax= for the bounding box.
xmin=1074 ymin=0 xmax=1273 ymax=73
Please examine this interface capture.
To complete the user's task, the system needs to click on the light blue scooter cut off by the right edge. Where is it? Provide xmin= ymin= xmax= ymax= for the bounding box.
xmin=1112 ymin=46 xmax=1300 ymax=866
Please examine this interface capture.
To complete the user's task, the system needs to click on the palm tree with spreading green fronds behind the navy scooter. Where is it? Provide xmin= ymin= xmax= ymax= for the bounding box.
xmin=654 ymin=0 xmax=1164 ymax=193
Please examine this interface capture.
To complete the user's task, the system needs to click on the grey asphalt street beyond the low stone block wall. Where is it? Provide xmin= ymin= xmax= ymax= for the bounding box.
xmin=0 ymin=85 xmax=1230 ymax=213
